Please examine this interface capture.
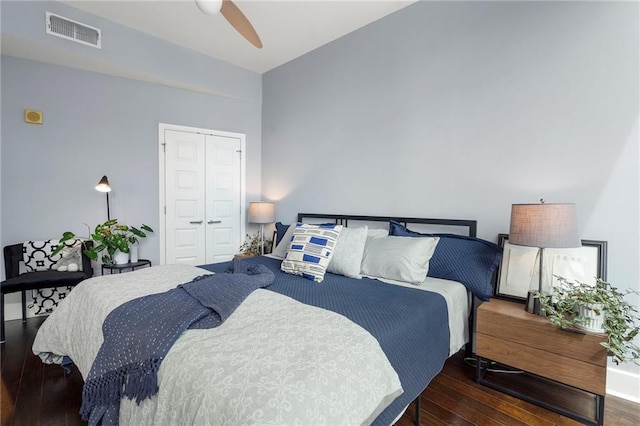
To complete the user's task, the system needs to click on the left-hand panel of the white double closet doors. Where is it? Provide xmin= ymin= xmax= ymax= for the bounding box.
xmin=165 ymin=130 xmax=206 ymax=266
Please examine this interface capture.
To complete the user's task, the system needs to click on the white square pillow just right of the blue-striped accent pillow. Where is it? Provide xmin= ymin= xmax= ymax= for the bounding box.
xmin=327 ymin=226 xmax=367 ymax=279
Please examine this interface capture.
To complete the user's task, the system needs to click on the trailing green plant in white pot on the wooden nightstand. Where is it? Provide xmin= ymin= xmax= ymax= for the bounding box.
xmin=536 ymin=276 xmax=640 ymax=365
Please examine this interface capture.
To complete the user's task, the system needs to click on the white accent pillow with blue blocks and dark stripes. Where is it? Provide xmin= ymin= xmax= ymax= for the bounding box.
xmin=280 ymin=223 xmax=342 ymax=283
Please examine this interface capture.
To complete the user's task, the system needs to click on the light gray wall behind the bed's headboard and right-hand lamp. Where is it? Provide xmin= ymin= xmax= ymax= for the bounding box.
xmin=262 ymin=2 xmax=640 ymax=382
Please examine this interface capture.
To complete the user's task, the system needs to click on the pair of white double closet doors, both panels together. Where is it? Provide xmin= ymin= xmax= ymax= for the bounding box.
xmin=160 ymin=128 xmax=244 ymax=266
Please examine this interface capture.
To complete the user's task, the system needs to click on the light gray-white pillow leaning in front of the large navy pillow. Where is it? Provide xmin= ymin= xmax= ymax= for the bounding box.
xmin=361 ymin=236 xmax=439 ymax=284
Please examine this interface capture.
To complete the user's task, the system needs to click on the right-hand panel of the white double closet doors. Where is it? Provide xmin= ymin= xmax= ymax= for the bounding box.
xmin=206 ymin=135 xmax=241 ymax=263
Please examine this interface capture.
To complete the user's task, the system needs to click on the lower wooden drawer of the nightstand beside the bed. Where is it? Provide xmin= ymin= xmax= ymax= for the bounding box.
xmin=476 ymin=333 xmax=607 ymax=395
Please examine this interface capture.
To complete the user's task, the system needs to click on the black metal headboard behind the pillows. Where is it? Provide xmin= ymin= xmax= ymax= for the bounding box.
xmin=298 ymin=213 xmax=478 ymax=237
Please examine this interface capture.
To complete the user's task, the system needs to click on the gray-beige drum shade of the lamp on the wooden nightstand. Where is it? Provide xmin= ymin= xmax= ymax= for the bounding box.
xmin=509 ymin=203 xmax=582 ymax=248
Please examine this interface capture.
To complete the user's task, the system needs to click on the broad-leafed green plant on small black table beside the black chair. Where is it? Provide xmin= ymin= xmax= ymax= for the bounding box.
xmin=53 ymin=219 xmax=153 ymax=265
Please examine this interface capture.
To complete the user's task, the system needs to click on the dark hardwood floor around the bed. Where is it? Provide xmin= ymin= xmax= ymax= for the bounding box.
xmin=0 ymin=318 xmax=640 ymax=426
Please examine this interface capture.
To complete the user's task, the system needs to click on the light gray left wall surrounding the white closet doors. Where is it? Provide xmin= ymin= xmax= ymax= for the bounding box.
xmin=0 ymin=2 xmax=262 ymax=317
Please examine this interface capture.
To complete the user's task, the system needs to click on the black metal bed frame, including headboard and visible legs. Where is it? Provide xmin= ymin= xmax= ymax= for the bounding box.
xmin=298 ymin=213 xmax=480 ymax=425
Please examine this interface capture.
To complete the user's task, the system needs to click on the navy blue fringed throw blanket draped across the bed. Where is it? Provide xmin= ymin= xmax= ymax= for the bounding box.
xmin=80 ymin=260 xmax=274 ymax=425
